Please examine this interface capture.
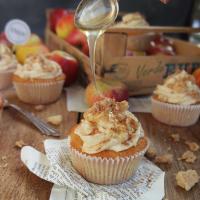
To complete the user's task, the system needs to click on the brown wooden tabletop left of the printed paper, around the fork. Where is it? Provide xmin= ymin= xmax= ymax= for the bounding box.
xmin=0 ymin=89 xmax=77 ymax=200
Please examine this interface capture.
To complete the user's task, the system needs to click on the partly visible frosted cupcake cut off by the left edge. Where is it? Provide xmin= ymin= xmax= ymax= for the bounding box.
xmin=0 ymin=44 xmax=17 ymax=90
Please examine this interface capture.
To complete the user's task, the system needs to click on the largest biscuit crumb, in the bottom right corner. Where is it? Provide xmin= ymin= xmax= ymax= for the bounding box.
xmin=176 ymin=169 xmax=199 ymax=191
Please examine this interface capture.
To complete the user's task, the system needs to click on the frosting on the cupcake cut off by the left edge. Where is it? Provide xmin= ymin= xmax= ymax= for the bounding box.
xmin=0 ymin=44 xmax=17 ymax=71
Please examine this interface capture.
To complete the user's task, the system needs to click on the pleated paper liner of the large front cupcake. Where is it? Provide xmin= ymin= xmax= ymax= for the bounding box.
xmin=68 ymin=140 xmax=148 ymax=185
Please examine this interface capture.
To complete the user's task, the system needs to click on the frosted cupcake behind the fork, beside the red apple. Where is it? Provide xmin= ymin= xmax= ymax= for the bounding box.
xmin=13 ymin=55 xmax=65 ymax=104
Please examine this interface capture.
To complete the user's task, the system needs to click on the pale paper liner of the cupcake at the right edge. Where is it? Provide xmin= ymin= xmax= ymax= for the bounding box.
xmin=151 ymin=98 xmax=200 ymax=127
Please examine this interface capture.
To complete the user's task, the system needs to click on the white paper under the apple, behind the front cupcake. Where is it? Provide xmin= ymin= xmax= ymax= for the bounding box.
xmin=66 ymin=85 xmax=151 ymax=113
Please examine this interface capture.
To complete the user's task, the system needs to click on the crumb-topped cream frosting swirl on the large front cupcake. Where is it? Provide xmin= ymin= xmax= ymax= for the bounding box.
xmin=75 ymin=98 xmax=144 ymax=154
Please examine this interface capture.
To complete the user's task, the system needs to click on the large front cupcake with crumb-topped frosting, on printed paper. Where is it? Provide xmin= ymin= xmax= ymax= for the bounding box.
xmin=68 ymin=98 xmax=148 ymax=185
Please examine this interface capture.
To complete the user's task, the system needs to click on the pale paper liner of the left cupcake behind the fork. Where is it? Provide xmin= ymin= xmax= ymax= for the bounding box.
xmin=13 ymin=80 xmax=64 ymax=104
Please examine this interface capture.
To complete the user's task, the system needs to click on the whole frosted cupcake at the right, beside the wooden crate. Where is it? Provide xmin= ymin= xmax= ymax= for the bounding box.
xmin=151 ymin=70 xmax=200 ymax=126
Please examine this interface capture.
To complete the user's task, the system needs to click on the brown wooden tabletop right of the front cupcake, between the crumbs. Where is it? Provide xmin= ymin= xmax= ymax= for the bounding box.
xmin=137 ymin=114 xmax=200 ymax=200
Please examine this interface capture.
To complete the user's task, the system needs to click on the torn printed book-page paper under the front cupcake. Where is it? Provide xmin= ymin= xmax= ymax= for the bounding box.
xmin=21 ymin=139 xmax=164 ymax=200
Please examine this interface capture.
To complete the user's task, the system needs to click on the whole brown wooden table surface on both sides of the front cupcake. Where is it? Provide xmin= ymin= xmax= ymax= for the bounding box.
xmin=0 ymin=90 xmax=200 ymax=200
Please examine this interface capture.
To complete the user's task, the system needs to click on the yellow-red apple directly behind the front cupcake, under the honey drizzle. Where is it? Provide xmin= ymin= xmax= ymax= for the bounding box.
xmin=85 ymin=78 xmax=129 ymax=106
